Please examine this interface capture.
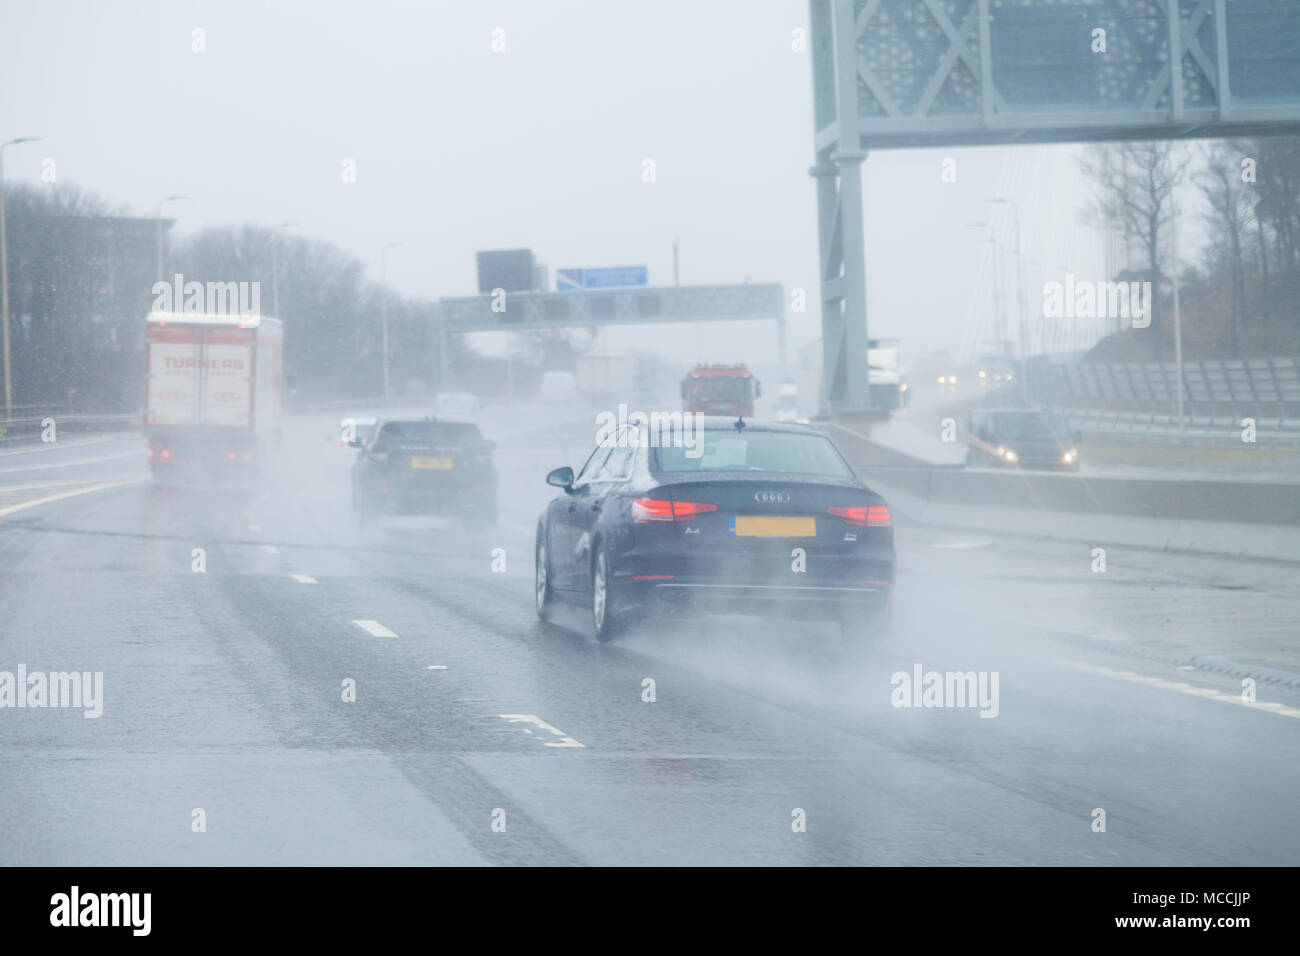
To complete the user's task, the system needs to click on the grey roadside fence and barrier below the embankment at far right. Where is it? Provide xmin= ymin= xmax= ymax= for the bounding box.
xmin=1027 ymin=358 xmax=1300 ymax=446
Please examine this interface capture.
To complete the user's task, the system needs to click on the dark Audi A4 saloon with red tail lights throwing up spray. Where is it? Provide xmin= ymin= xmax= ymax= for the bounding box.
xmin=536 ymin=418 xmax=894 ymax=640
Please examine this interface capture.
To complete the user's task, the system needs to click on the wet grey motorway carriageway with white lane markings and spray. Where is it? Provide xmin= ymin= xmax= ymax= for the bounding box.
xmin=0 ymin=412 xmax=1300 ymax=864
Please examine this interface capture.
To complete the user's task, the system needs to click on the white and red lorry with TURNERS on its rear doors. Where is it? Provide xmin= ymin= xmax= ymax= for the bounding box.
xmin=144 ymin=312 xmax=283 ymax=483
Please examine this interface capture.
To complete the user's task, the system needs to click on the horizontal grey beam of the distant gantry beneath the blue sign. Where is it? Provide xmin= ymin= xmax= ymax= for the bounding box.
xmin=438 ymin=282 xmax=785 ymax=333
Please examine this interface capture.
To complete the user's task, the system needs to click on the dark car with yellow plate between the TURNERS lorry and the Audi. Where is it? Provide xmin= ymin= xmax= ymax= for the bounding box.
xmin=351 ymin=419 xmax=497 ymax=525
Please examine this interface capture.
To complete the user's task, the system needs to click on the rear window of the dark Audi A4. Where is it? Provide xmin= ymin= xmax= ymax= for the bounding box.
xmin=654 ymin=431 xmax=854 ymax=479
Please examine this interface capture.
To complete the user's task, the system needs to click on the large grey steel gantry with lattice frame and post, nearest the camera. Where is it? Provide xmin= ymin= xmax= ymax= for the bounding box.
xmin=809 ymin=0 xmax=1300 ymax=407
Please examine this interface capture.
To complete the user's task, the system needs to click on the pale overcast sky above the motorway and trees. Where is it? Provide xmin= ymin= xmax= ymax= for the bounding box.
xmin=0 ymin=0 xmax=1128 ymax=363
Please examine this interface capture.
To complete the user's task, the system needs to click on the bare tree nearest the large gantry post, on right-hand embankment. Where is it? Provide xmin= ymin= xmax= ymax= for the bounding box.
xmin=1079 ymin=140 xmax=1190 ymax=336
